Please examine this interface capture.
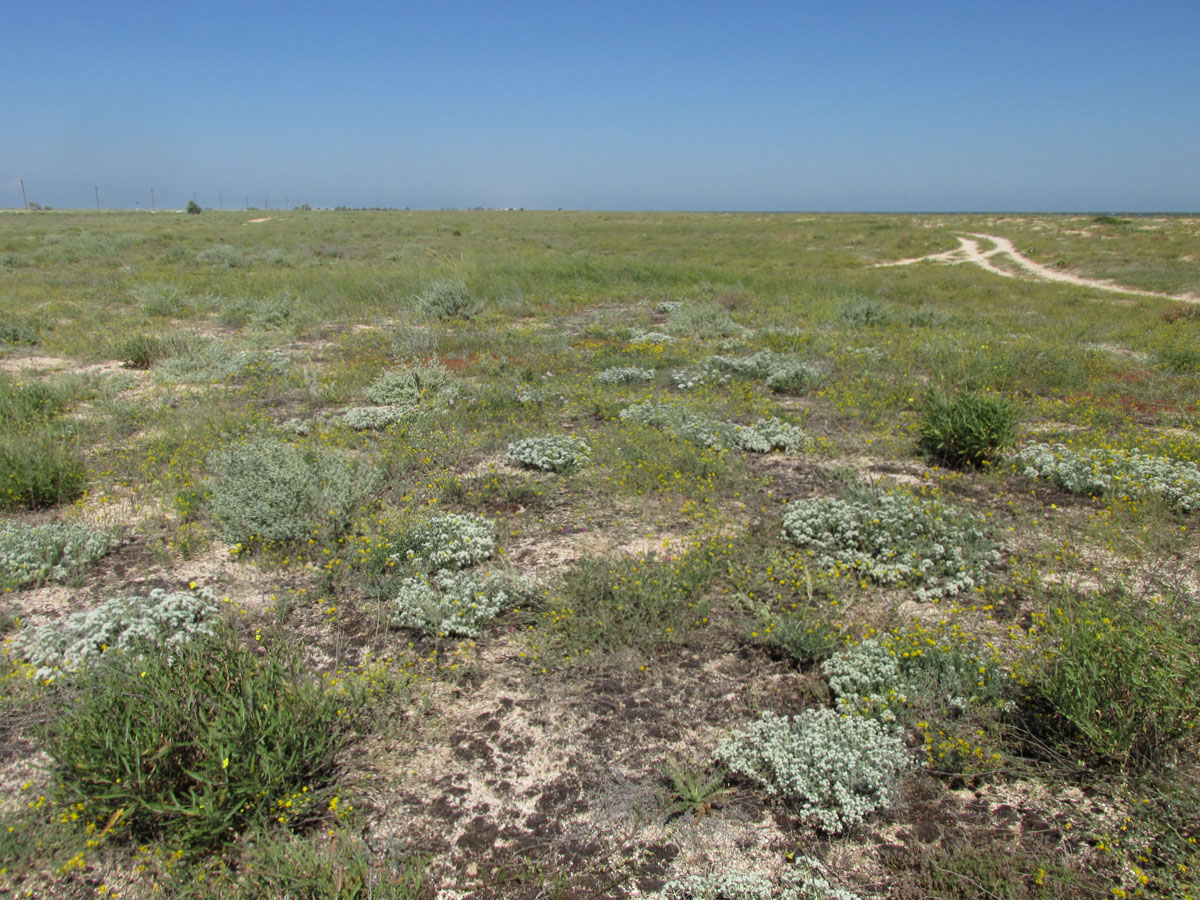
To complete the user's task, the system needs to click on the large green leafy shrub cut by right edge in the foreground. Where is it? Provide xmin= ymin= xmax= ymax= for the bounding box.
xmin=1024 ymin=589 xmax=1200 ymax=767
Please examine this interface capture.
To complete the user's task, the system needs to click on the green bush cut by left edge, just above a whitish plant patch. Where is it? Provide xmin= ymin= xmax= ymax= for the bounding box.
xmin=0 ymin=430 xmax=88 ymax=509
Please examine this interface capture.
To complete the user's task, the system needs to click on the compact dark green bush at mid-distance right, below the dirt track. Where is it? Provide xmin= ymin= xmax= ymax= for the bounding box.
xmin=917 ymin=391 xmax=1016 ymax=469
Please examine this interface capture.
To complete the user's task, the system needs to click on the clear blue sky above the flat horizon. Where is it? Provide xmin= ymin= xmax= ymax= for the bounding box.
xmin=0 ymin=0 xmax=1200 ymax=211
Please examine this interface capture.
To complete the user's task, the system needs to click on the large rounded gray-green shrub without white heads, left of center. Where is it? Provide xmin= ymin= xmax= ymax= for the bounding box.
xmin=205 ymin=438 xmax=378 ymax=544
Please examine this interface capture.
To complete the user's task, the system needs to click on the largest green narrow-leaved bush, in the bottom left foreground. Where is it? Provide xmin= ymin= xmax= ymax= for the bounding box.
xmin=41 ymin=630 xmax=355 ymax=852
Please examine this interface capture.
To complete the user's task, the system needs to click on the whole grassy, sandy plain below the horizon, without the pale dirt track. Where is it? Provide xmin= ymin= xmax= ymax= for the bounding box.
xmin=0 ymin=211 xmax=1200 ymax=900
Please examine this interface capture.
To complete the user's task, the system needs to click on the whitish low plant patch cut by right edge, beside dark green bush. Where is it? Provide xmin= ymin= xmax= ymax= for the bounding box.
xmin=1015 ymin=443 xmax=1200 ymax=512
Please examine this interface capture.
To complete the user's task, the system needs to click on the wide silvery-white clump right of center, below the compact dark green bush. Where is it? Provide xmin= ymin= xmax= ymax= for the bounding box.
xmin=784 ymin=490 xmax=1000 ymax=600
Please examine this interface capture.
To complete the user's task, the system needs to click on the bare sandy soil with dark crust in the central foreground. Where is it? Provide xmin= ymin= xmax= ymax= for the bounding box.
xmin=361 ymin=637 xmax=802 ymax=900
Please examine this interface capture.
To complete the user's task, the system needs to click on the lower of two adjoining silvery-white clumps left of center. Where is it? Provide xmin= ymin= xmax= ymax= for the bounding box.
xmin=390 ymin=570 xmax=529 ymax=637
